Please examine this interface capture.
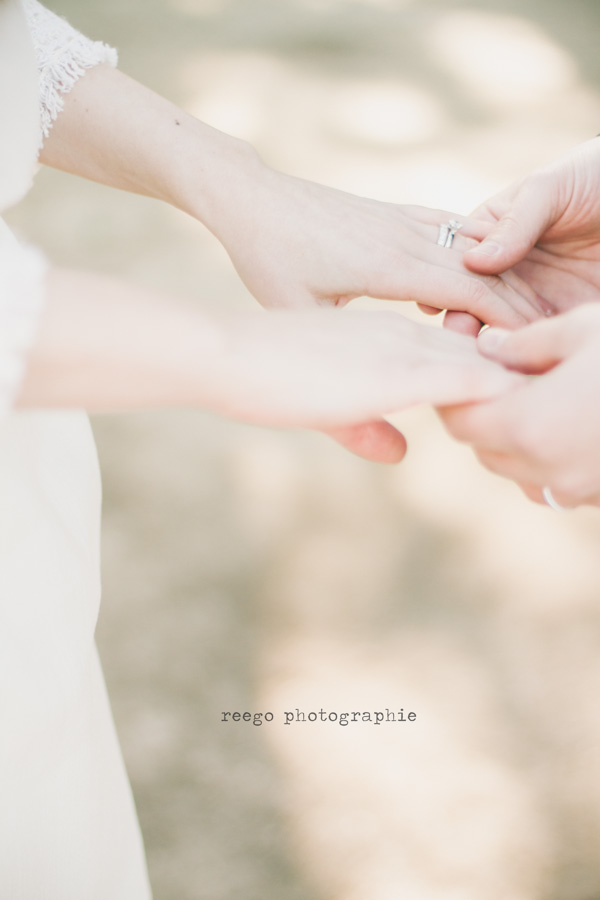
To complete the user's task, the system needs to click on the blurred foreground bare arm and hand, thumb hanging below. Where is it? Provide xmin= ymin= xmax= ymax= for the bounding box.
xmin=19 ymin=270 xmax=522 ymax=462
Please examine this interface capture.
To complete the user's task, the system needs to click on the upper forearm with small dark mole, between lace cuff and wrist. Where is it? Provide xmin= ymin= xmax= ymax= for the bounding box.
xmin=40 ymin=66 xmax=262 ymax=231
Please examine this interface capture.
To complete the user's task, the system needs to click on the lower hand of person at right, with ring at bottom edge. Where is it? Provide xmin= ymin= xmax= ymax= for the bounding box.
xmin=440 ymin=304 xmax=600 ymax=507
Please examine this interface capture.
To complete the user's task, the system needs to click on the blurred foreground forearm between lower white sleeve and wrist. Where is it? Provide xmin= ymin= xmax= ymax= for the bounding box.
xmin=17 ymin=269 xmax=229 ymax=411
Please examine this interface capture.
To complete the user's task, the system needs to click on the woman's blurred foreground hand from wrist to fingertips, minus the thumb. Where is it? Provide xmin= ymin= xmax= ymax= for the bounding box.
xmin=216 ymin=310 xmax=522 ymax=429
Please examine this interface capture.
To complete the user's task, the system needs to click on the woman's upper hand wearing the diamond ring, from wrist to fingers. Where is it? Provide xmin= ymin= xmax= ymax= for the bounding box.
xmin=202 ymin=158 xmax=540 ymax=328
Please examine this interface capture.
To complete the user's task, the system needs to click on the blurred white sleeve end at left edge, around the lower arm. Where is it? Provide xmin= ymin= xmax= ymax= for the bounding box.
xmin=0 ymin=239 xmax=47 ymax=419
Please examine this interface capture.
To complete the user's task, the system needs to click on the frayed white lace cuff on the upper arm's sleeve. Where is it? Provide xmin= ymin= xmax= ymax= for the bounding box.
xmin=22 ymin=0 xmax=117 ymax=138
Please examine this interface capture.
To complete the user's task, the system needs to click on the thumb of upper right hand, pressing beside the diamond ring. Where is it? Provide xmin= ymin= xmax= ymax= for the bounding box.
xmin=464 ymin=174 xmax=554 ymax=275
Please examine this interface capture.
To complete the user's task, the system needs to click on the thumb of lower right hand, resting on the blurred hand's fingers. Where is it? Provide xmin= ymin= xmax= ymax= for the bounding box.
xmin=477 ymin=314 xmax=581 ymax=375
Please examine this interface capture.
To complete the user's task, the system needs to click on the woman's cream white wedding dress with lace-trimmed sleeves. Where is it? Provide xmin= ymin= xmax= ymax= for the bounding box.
xmin=0 ymin=0 xmax=150 ymax=900
